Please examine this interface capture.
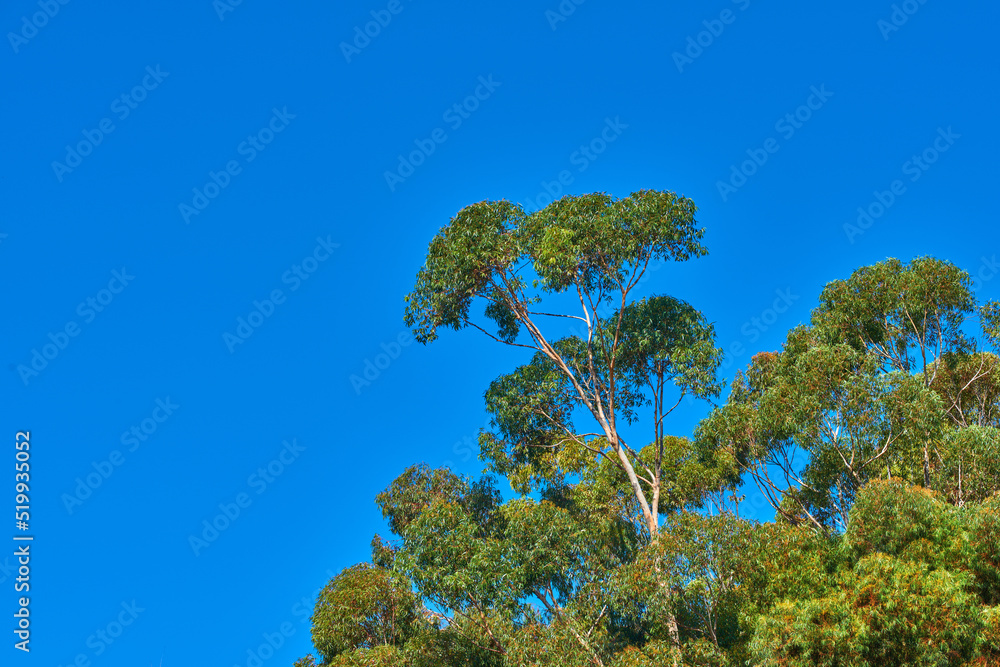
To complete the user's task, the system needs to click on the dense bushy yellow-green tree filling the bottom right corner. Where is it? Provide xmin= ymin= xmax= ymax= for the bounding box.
xmin=751 ymin=481 xmax=1000 ymax=667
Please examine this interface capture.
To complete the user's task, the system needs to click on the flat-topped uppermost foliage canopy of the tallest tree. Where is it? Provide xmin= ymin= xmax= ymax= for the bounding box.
xmin=405 ymin=190 xmax=705 ymax=342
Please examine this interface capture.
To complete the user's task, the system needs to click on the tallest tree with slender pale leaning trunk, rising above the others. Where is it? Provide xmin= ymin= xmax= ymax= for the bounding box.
xmin=405 ymin=190 xmax=721 ymax=664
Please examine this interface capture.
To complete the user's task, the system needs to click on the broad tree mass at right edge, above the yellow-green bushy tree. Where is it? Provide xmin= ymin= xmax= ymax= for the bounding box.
xmin=699 ymin=257 xmax=1000 ymax=530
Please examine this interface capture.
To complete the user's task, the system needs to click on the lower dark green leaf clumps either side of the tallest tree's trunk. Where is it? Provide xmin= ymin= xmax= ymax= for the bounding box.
xmin=480 ymin=297 xmax=735 ymax=505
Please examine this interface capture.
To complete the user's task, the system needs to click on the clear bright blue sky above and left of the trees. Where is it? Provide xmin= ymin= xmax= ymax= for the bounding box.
xmin=0 ymin=0 xmax=1000 ymax=667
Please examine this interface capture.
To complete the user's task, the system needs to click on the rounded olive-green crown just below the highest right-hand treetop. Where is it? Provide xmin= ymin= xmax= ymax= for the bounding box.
xmin=697 ymin=327 xmax=944 ymax=529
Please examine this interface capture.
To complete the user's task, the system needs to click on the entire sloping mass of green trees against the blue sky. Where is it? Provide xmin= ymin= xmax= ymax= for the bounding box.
xmin=296 ymin=190 xmax=1000 ymax=667
